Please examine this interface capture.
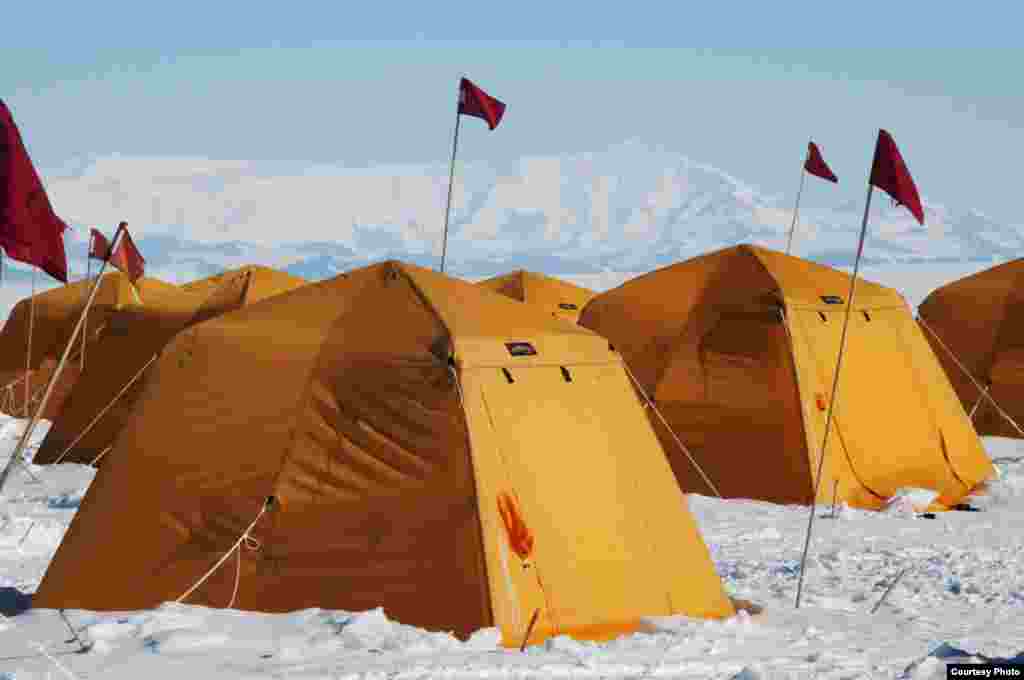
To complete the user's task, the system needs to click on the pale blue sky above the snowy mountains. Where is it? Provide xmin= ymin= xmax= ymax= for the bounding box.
xmin=0 ymin=0 xmax=1024 ymax=224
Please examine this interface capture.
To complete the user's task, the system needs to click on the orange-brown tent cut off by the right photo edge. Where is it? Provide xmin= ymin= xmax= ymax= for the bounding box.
xmin=918 ymin=259 xmax=1024 ymax=438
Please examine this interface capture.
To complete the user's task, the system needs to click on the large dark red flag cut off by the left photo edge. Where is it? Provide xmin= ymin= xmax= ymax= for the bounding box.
xmin=0 ymin=100 xmax=68 ymax=284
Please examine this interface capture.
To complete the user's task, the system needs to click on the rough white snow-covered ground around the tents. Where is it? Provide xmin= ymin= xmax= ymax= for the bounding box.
xmin=0 ymin=419 xmax=1024 ymax=680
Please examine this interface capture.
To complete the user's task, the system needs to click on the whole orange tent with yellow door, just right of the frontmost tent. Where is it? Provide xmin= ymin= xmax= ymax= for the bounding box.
xmin=580 ymin=245 xmax=993 ymax=508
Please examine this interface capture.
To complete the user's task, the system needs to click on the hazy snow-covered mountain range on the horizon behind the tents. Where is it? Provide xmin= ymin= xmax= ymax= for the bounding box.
xmin=8 ymin=141 xmax=1024 ymax=281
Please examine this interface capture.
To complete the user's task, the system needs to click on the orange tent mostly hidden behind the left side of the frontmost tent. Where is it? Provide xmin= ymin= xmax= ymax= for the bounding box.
xmin=34 ymin=267 xmax=305 ymax=465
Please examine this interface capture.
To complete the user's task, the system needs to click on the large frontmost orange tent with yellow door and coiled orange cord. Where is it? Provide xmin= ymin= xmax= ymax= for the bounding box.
xmin=33 ymin=262 xmax=734 ymax=645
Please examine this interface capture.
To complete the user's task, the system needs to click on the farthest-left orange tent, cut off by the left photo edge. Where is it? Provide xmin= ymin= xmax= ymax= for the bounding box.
xmin=0 ymin=271 xmax=187 ymax=419
